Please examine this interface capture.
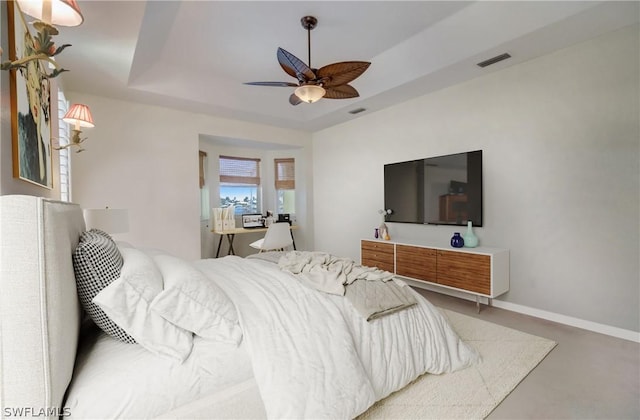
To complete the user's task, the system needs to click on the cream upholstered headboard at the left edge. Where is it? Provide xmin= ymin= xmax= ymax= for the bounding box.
xmin=0 ymin=195 xmax=85 ymax=418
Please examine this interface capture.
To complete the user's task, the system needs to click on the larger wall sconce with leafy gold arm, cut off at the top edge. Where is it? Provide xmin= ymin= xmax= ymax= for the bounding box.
xmin=0 ymin=0 xmax=84 ymax=78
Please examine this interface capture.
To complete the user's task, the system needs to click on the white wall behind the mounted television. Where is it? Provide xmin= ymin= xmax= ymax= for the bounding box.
xmin=313 ymin=25 xmax=640 ymax=331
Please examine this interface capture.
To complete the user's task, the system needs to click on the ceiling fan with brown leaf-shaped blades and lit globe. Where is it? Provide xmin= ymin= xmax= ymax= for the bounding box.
xmin=245 ymin=16 xmax=371 ymax=105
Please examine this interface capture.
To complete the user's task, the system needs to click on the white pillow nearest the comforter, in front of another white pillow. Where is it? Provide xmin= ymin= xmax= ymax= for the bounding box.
xmin=151 ymin=254 xmax=242 ymax=344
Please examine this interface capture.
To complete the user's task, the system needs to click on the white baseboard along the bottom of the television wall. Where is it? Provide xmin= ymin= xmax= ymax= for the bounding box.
xmin=410 ymin=278 xmax=640 ymax=343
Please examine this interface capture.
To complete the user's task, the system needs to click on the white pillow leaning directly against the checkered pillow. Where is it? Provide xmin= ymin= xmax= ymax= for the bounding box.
xmin=93 ymin=248 xmax=193 ymax=362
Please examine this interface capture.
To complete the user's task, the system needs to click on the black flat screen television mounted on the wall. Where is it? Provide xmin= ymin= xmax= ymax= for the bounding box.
xmin=384 ymin=150 xmax=482 ymax=226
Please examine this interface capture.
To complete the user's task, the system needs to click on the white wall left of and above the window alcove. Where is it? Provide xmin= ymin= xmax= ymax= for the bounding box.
xmin=67 ymin=92 xmax=310 ymax=259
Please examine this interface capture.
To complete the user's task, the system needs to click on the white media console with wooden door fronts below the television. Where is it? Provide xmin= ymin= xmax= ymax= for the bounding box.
xmin=360 ymin=239 xmax=509 ymax=298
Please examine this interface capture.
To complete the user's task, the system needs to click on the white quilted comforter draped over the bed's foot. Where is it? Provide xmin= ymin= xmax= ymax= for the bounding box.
xmin=195 ymin=256 xmax=478 ymax=419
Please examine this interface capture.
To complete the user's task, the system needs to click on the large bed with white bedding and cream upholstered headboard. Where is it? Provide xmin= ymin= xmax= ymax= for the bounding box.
xmin=0 ymin=196 xmax=478 ymax=419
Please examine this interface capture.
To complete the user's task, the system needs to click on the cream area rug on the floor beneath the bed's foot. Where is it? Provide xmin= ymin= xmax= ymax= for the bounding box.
xmin=358 ymin=309 xmax=556 ymax=420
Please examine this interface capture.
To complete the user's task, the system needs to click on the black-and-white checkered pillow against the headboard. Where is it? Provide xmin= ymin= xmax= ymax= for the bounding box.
xmin=73 ymin=229 xmax=136 ymax=343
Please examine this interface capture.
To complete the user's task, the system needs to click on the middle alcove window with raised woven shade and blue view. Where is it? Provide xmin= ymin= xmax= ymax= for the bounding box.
xmin=220 ymin=156 xmax=260 ymax=215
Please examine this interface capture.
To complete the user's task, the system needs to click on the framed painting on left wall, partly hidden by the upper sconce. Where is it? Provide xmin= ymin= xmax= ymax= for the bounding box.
xmin=7 ymin=1 xmax=53 ymax=189
